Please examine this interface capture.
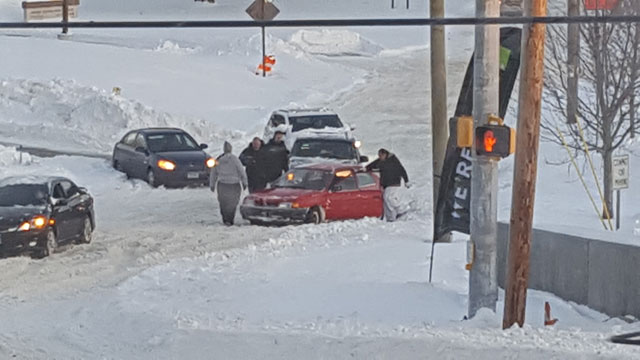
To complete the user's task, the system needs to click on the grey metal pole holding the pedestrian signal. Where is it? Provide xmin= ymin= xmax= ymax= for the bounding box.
xmin=469 ymin=0 xmax=500 ymax=317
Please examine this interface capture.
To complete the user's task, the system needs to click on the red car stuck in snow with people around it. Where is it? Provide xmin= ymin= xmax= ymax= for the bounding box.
xmin=240 ymin=164 xmax=382 ymax=224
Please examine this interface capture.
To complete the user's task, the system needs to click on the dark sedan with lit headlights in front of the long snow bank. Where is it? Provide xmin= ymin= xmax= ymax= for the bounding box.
xmin=112 ymin=128 xmax=216 ymax=187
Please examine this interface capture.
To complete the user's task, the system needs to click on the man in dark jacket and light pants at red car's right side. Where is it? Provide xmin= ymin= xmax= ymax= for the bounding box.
xmin=367 ymin=149 xmax=409 ymax=221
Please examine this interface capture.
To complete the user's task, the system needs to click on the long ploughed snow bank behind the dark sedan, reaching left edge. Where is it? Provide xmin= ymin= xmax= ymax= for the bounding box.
xmin=0 ymin=80 xmax=242 ymax=154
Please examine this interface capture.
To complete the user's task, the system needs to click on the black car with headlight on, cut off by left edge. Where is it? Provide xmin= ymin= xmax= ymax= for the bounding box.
xmin=0 ymin=176 xmax=95 ymax=257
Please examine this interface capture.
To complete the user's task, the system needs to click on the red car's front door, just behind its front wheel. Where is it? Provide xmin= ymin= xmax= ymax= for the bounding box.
xmin=326 ymin=172 xmax=361 ymax=220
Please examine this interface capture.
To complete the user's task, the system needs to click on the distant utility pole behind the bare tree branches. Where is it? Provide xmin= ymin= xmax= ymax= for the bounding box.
xmin=567 ymin=0 xmax=581 ymax=124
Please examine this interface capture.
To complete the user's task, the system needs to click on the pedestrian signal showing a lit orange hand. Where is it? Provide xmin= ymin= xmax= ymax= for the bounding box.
xmin=476 ymin=125 xmax=516 ymax=158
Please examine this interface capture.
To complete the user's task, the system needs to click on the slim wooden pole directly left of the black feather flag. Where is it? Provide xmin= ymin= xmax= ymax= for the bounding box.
xmin=429 ymin=0 xmax=450 ymax=243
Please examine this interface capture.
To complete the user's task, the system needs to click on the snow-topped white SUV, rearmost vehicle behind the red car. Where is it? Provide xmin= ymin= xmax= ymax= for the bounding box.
xmin=264 ymin=109 xmax=356 ymax=150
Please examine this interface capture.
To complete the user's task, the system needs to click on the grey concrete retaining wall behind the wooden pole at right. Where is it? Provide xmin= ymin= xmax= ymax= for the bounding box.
xmin=498 ymin=224 xmax=640 ymax=318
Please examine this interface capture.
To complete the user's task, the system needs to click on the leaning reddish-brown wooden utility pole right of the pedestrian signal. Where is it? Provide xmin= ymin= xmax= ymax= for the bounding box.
xmin=502 ymin=0 xmax=547 ymax=329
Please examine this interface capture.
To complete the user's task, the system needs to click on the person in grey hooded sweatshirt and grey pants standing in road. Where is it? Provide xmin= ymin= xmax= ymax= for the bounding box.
xmin=209 ymin=141 xmax=247 ymax=225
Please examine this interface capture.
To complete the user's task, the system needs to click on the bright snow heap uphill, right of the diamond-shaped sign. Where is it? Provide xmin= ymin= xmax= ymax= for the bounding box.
xmin=290 ymin=29 xmax=382 ymax=56
